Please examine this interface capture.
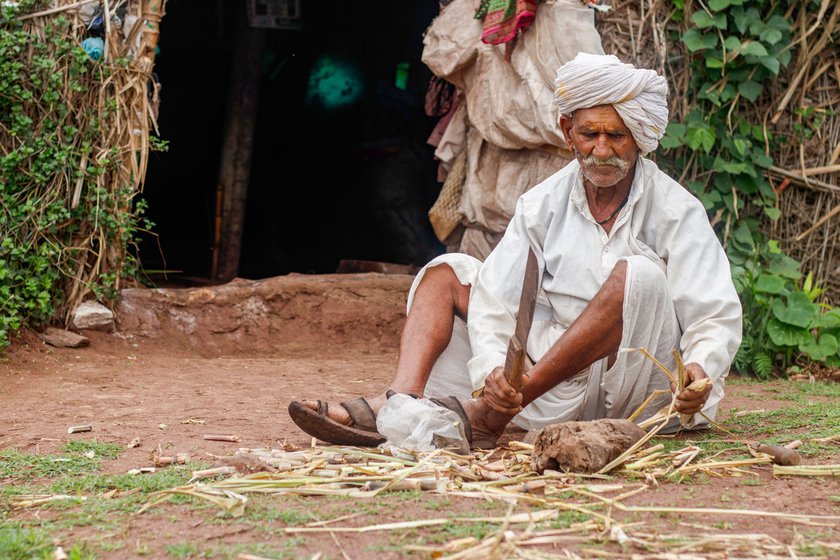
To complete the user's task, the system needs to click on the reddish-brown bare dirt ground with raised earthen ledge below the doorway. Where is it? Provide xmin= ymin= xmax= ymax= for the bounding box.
xmin=0 ymin=274 xmax=840 ymax=559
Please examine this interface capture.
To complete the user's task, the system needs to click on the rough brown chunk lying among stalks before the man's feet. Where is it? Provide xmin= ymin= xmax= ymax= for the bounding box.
xmin=531 ymin=418 xmax=645 ymax=473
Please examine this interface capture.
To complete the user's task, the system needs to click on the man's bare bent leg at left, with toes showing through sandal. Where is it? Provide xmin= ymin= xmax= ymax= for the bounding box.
xmin=296 ymin=264 xmax=470 ymax=425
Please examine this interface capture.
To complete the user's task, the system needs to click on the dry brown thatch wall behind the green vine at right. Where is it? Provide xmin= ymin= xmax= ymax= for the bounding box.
xmin=596 ymin=0 xmax=840 ymax=304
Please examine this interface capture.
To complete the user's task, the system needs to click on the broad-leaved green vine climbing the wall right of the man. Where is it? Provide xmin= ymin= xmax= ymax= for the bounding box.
xmin=662 ymin=0 xmax=840 ymax=378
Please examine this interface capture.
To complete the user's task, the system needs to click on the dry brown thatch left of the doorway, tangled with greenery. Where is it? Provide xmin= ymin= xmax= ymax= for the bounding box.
xmin=0 ymin=0 xmax=165 ymax=324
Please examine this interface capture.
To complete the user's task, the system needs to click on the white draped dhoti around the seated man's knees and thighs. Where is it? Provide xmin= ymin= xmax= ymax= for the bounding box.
xmin=408 ymin=253 xmax=723 ymax=430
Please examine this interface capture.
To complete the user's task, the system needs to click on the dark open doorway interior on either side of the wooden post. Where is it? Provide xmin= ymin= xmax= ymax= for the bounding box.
xmin=141 ymin=0 xmax=444 ymax=283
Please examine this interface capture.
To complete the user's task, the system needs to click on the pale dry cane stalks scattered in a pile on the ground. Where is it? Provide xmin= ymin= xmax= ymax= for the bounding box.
xmin=126 ymin=349 xmax=840 ymax=559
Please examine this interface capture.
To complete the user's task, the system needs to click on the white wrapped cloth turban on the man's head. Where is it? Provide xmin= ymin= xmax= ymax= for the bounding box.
xmin=554 ymin=53 xmax=668 ymax=154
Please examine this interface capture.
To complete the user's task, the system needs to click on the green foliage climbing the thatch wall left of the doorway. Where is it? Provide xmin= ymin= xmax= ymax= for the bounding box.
xmin=0 ymin=0 xmax=153 ymax=349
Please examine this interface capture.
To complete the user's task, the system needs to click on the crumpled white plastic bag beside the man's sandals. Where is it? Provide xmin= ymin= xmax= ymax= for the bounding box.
xmin=376 ymin=394 xmax=470 ymax=453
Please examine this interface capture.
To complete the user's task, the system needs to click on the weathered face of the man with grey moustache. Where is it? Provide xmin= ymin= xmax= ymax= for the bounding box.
xmin=560 ymin=105 xmax=639 ymax=187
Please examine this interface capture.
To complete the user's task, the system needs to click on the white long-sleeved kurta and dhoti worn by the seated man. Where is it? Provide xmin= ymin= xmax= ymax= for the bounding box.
xmin=409 ymin=158 xmax=742 ymax=428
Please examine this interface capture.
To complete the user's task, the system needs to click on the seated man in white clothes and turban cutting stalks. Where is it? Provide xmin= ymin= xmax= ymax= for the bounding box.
xmin=289 ymin=54 xmax=742 ymax=447
